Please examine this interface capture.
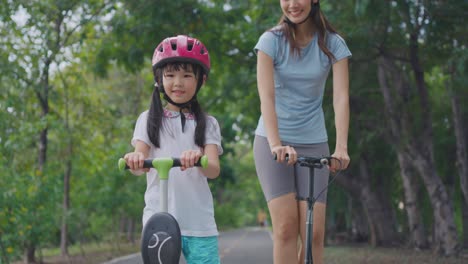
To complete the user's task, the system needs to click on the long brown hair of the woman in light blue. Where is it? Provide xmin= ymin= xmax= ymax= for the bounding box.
xmin=270 ymin=0 xmax=337 ymax=61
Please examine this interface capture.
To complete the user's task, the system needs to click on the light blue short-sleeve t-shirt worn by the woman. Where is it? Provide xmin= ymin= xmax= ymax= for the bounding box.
xmin=254 ymin=28 xmax=351 ymax=144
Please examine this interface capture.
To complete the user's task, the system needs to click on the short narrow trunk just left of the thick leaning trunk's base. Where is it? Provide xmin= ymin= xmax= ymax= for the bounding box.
xmin=397 ymin=151 xmax=428 ymax=249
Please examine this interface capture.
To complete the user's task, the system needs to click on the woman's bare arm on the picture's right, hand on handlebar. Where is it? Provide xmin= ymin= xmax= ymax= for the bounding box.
xmin=330 ymin=59 xmax=350 ymax=171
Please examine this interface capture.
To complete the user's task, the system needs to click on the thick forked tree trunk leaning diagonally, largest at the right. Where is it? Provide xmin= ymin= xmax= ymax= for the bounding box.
xmin=378 ymin=55 xmax=458 ymax=255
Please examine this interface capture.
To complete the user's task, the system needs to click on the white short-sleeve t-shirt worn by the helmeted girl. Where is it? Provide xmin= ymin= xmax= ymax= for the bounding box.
xmin=132 ymin=110 xmax=223 ymax=237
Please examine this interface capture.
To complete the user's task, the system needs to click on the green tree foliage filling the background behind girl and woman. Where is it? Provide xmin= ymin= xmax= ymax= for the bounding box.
xmin=0 ymin=0 xmax=468 ymax=261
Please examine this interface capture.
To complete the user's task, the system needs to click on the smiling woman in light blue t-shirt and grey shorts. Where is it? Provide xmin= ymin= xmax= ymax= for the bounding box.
xmin=254 ymin=0 xmax=351 ymax=264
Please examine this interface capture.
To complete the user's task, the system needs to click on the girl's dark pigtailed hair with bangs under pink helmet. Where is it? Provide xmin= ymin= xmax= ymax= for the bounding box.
xmin=146 ymin=62 xmax=206 ymax=148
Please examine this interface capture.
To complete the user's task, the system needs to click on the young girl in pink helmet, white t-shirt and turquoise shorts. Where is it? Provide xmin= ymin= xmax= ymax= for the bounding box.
xmin=124 ymin=35 xmax=223 ymax=264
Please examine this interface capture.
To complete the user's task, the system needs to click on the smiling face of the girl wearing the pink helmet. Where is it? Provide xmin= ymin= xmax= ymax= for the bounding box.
xmin=163 ymin=64 xmax=198 ymax=111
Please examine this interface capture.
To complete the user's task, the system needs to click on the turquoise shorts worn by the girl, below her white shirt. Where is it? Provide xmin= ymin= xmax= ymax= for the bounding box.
xmin=182 ymin=236 xmax=220 ymax=264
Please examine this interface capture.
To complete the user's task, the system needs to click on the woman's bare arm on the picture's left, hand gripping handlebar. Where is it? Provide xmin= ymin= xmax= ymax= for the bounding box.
xmin=257 ymin=51 xmax=296 ymax=164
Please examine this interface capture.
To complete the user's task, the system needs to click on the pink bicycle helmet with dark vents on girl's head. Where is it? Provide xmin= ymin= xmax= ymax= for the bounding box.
xmin=152 ymin=35 xmax=210 ymax=74
